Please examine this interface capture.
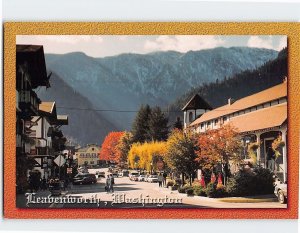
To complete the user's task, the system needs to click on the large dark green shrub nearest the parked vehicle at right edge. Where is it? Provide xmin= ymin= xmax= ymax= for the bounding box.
xmin=226 ymin=168 xmax=274 ymax=196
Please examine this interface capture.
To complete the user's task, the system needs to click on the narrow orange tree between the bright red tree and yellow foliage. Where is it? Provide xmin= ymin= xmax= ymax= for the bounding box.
xmin=116 ymin=131 xmax=132 ymax=164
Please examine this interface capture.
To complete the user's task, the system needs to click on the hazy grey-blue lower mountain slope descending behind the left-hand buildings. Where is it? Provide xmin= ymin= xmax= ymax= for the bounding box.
xmin=37 ymin=73 xmax=117 ymax=145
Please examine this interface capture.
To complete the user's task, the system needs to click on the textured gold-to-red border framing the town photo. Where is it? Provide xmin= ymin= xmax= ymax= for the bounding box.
xmin=4 ymin=22 xmax=300 ymax=219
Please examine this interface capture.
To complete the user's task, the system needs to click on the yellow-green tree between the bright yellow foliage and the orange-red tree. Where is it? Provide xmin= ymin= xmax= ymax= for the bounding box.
xmin=165 ymin=130 xmax=199 ymax=184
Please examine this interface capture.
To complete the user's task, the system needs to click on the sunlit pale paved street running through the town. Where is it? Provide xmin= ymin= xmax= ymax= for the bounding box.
xmin=53 ymin=169 xmax=286 ymax=208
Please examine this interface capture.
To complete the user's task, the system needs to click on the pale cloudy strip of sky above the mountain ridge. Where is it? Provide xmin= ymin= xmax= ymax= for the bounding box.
xmin=16 ymin=35 xmax=287 ymax=57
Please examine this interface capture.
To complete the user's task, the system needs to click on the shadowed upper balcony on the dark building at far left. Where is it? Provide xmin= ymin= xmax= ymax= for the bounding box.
xmin=18 ymin=90 xmax=41 ymax=114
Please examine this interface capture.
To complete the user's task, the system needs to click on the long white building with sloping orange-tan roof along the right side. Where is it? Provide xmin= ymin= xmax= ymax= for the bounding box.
xmin=183 ymin=79 xmax=287 ymax=181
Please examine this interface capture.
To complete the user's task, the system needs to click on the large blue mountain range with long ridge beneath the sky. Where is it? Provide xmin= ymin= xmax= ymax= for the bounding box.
xmin=46 ymin=47 xmax=278 ymax=134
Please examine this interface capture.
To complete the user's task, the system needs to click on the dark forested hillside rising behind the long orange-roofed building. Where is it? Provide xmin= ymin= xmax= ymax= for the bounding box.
xmin=169 ymin=48 xmax=288 ymax=122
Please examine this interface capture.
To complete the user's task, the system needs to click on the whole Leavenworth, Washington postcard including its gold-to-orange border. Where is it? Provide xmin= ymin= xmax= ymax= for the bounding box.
xmin=4 ymin=22 xmax=300 ymax=219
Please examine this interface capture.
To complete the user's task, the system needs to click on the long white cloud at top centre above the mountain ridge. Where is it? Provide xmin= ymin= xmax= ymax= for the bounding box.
xmin=144 ymin=35 xmax=225 ymax=52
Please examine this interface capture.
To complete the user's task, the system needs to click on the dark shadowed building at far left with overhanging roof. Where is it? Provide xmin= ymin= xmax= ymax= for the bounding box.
xmin=16 ymin=45 xmax=50 ymax=192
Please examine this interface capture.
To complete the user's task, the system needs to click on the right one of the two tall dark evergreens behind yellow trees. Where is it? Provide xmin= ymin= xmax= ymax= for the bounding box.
xmin=147 ymin=106 xmax=169 ymax=141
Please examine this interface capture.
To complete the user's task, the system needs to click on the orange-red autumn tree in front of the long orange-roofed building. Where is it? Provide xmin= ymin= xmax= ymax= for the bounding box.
xmin=197 ymin=124 xmax=243 ymax=184
